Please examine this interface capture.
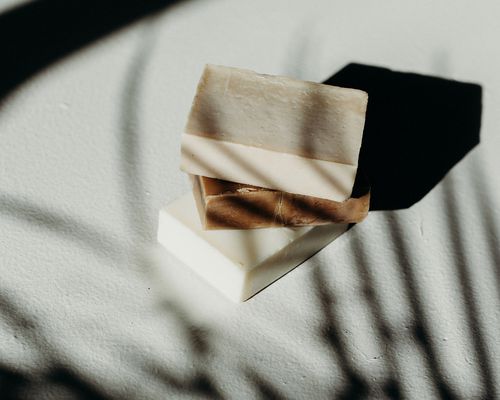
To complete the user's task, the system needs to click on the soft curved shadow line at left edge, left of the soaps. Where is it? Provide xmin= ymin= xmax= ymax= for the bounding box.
xmin=0 ymin=193 xmax=130 ymax=261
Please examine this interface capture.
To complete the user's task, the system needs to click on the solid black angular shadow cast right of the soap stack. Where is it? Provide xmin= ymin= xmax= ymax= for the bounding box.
xmin=323 ymin=64 xmax=482 ymax=210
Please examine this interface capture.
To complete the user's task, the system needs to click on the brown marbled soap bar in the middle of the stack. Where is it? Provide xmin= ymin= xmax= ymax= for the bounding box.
xmin=191 ymin=175 xmax=370 ymax=229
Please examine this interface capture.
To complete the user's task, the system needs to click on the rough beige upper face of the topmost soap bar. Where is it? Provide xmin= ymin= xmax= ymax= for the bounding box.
xmin=185 ymin=65 xmax=368 ymax=165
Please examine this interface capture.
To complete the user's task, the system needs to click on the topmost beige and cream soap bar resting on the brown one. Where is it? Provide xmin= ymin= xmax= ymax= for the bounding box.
xmin=181 ymin=65 xmax=368 ymax=201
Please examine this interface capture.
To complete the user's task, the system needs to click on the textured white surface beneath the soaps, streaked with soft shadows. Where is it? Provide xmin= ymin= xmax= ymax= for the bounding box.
xmin=0 ymin=0 xmax=500 ymax=399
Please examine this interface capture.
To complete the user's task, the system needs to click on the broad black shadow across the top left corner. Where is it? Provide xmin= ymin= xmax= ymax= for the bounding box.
xmin=0 ymin=0 xmax=185 ymax=104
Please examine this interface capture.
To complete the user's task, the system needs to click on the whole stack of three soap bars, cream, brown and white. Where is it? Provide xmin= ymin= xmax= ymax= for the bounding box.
xmin=158 ymin=65 xmax=370 ymax=301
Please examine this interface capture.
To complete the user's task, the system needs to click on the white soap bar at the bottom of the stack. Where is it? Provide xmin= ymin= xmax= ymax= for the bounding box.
xmin=158 ymin=193 xmax=348 ymax=301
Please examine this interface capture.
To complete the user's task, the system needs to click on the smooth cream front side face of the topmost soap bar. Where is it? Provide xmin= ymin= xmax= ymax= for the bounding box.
xmin=181 ymin=134 xmax=357 ymax=201
